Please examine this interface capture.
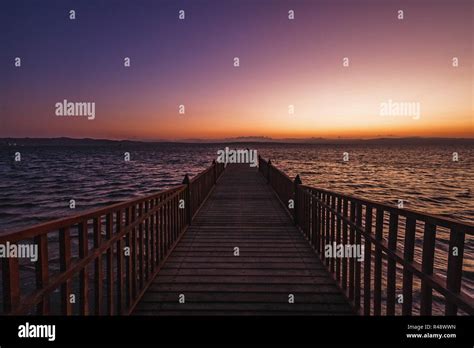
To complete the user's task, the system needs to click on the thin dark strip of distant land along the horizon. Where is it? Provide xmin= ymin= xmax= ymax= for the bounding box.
xmin=0 ymin=136 xmax=474 ymax=146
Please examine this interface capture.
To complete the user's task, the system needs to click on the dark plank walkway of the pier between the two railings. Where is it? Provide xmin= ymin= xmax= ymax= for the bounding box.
xmin=134 ymin=165 xmax=353 ymax=315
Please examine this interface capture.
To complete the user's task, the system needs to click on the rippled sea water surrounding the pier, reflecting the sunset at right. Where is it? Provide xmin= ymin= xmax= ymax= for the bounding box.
xmin=0 ymin=143 xmax=474 ymax=312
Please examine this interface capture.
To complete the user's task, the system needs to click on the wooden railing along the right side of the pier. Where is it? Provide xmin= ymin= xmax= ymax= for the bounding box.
xmin=259 ymin=158 xmax=474 ymax=315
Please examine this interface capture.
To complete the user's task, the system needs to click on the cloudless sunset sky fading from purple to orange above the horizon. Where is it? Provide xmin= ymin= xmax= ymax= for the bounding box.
xmin=0 ymin=0 xmax=474 ymax=140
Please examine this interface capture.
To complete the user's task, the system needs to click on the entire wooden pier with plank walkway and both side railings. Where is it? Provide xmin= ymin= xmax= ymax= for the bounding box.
xmin=0 ymin=158 xmax=474 ymax=315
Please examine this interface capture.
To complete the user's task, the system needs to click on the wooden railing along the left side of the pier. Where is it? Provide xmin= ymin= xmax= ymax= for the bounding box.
xmin=0 ymin=162 xmax=224 ymax=315
